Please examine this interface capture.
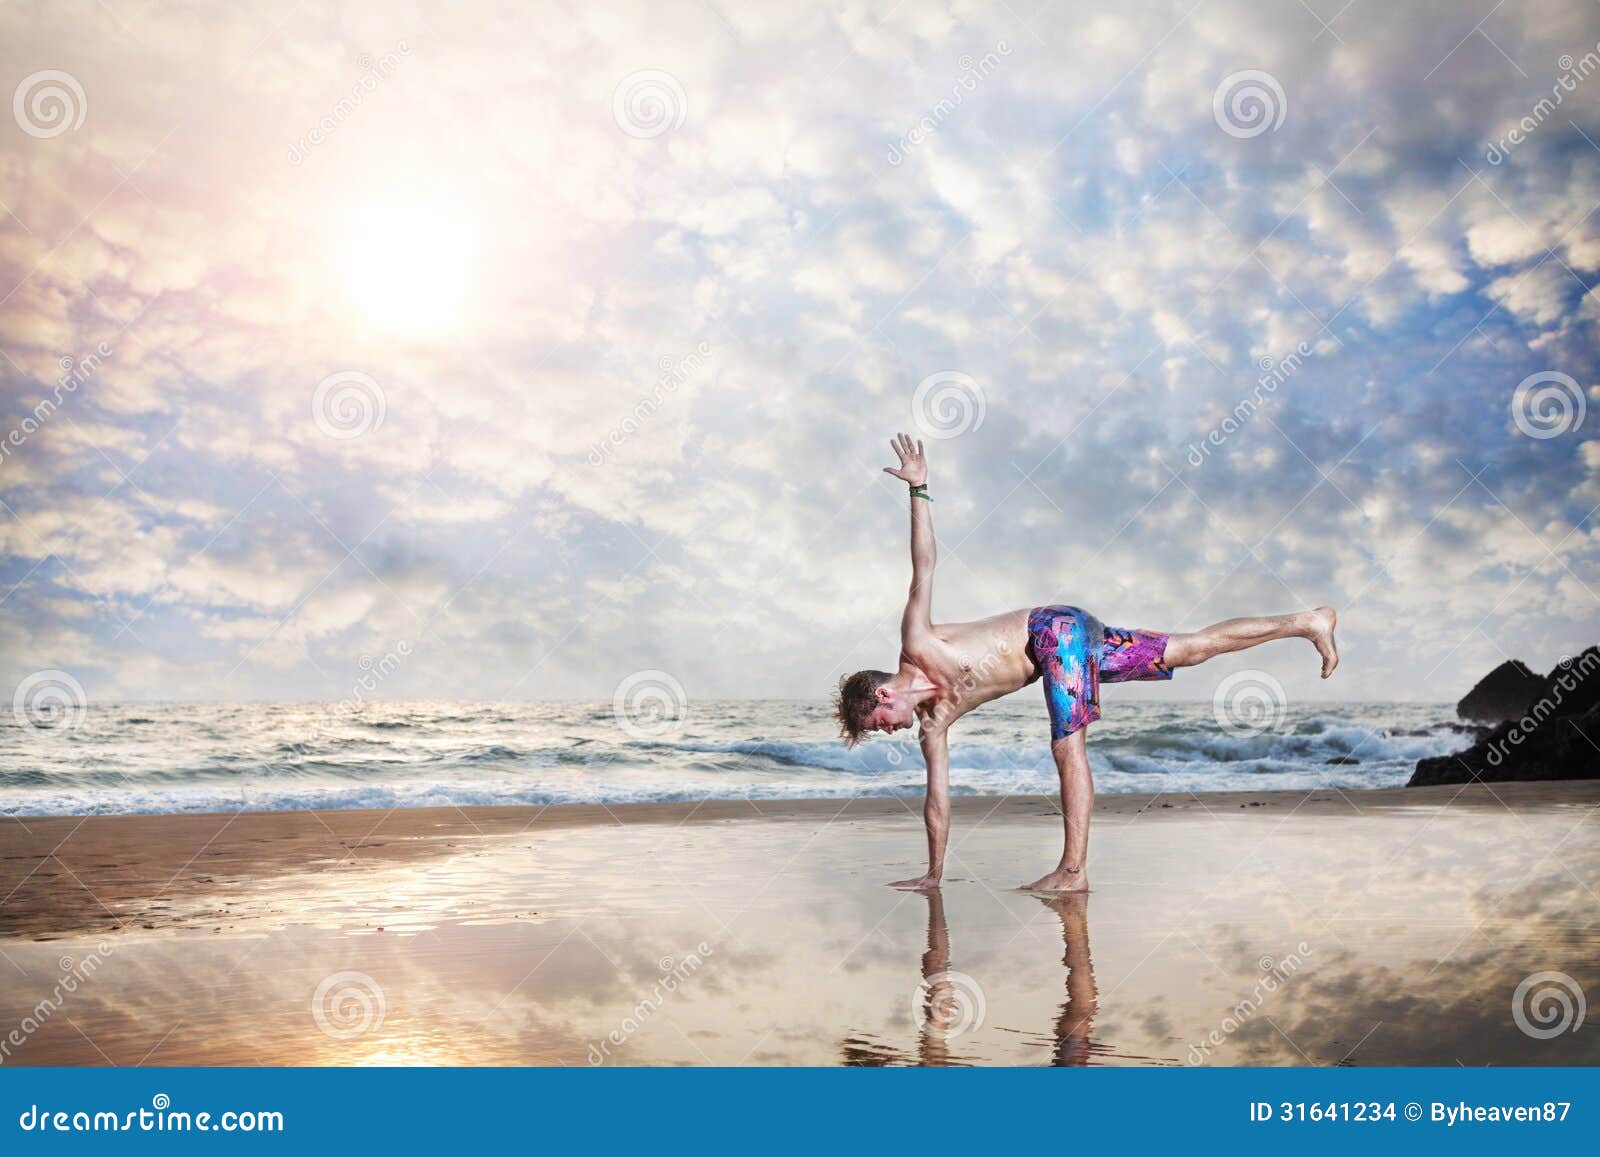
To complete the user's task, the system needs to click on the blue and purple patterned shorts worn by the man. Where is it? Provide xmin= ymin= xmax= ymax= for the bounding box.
xmin=1027 ymin=607 xmax=1173 ymax=739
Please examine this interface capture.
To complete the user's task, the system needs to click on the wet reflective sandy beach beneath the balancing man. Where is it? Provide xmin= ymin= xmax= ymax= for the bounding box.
xmin=0 ymin=783 xmax=1600 ymax=1066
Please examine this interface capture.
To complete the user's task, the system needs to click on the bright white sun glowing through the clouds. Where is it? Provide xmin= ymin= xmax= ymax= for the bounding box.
xmin=341 ymin=202 xmax=472 ymax=334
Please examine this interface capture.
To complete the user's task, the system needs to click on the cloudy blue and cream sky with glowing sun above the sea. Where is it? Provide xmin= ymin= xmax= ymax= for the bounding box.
xmin=0 ymin=0 xmax=1600 ymax=703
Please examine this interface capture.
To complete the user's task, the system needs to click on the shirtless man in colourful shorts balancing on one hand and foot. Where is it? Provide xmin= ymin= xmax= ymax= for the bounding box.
xmin=835 ymin=434 xmax=1339 ymax=891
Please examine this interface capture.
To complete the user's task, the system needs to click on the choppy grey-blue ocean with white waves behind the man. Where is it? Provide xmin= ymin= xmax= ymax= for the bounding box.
xmin=0 ymin=696 xmax=1469 ymax=816
